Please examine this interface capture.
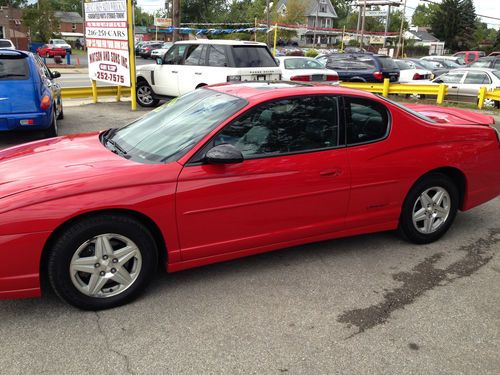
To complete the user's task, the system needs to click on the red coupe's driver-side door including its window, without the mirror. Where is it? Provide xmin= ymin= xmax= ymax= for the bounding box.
xmin=176 ymin=96 xmax=350 ymax=260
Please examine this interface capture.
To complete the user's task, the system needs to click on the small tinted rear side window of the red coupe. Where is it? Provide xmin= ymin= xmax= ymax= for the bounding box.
xmin=345 ymin=97 xmax=389 ymax=145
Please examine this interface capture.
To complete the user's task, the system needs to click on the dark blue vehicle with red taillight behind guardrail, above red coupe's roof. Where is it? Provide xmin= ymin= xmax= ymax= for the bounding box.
xmin=325 ymin=53 xmax=399 ymax=82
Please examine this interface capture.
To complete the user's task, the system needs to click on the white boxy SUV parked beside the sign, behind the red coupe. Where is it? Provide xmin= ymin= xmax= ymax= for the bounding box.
xmin=137 ymin=39 xmax=281 ymax=107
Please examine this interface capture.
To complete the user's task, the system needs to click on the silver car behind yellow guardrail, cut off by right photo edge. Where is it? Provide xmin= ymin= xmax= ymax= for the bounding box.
xmin=433 ymin=68 xmax=500 ymax=108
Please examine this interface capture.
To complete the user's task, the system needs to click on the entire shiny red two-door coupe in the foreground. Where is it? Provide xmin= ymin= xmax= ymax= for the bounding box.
xmin=0 ymin=82 xmax=500 ymax=310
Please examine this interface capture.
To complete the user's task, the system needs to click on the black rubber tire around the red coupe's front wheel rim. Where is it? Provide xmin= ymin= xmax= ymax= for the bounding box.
xmin=47 ymin=214 xmax=158 ymax=311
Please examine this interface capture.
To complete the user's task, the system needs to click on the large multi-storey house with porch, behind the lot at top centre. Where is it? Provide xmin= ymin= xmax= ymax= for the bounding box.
xmin=277 ymin=0 xmax=339 ymax=45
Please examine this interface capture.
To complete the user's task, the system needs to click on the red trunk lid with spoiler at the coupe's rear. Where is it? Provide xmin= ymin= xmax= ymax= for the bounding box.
xmin=405 ymin=104 xmax=495 ymax=125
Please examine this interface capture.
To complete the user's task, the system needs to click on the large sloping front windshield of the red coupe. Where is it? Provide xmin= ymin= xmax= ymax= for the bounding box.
xmin=102 ymin=89 xmax=247 ymax=163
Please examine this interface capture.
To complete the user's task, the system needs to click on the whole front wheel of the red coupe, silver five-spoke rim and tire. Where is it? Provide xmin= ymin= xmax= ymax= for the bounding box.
xmin=48 ymin=214 xmax=158 ymax=310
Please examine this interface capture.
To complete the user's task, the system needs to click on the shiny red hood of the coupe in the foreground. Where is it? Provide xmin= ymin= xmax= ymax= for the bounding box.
xmin=0 ymin=133 xmax=179 ymax=212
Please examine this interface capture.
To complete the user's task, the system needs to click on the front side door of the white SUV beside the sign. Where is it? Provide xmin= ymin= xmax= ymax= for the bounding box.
xmin=151 ymin=44 xmax=188 ymax=96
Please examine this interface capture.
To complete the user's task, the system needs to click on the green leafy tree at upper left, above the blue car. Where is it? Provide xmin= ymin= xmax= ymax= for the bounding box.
xmin=23 ymin=0 xmax=59 ymax=42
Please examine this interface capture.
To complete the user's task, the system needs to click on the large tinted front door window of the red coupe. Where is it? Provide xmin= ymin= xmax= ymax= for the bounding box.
xmin=213 ymin=96 xmax=339 ymax=159
